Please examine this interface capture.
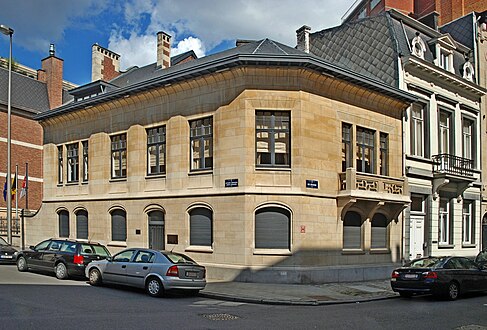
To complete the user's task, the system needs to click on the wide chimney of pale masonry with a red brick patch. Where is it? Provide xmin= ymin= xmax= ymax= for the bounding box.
xmin=91 ymin=44 xmax=120 ymax=81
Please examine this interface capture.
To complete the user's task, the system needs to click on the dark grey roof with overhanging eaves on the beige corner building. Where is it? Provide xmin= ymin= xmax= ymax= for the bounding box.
xmin=35 ymin=39 xmax=417 ymax=120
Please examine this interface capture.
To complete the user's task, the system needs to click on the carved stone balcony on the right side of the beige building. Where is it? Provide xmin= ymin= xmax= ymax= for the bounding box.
xmin=337 ymin=168 xmax=411 ymax=219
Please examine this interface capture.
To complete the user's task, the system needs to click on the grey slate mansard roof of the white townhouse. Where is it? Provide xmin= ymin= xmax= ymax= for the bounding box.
xmin=310 ymin=10 xmax=474 ymax=87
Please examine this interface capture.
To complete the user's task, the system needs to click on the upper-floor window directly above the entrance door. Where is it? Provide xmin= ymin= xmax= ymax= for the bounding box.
xmin=147 ymin=126 xmax=166 ymax=175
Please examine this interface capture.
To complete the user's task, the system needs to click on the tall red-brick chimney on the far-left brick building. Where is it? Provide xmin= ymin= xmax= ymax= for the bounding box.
xmin=37 ymin=44 xmax=64 ymax=109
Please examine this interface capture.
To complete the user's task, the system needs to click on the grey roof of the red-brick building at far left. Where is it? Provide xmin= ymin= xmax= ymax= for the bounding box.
xmin=0 ymin=68 xmax=49 ymax=114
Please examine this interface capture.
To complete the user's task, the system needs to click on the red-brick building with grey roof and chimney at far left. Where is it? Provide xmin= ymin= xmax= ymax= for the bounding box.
xmin=0 ymin=46 xmax=73 ymax=246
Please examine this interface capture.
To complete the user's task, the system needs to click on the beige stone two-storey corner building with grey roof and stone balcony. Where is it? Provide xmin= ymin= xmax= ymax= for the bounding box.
xmin=27 ymin=35 xmax=417 ymax=283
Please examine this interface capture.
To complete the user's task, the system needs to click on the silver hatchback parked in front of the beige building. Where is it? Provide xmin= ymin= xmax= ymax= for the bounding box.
xmin=86 ymin=248 xmax=206 ymax=297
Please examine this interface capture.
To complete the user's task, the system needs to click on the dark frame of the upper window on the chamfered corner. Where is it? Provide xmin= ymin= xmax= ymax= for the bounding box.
xmin=255 ymin=110 xmax=291 ymax=168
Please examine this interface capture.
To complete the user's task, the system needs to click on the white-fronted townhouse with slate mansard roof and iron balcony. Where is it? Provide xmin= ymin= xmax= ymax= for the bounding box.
xmin=306 ymin=10 xmax=485 ymax=259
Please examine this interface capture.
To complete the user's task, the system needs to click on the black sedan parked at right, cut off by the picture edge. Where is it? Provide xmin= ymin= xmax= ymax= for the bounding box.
xmin=391 ymin=257 xmax=487 ymax=300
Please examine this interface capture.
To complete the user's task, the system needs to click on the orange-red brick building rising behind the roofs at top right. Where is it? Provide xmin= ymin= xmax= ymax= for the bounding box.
xmin=342 ymin=0 xmax=487 ymax=25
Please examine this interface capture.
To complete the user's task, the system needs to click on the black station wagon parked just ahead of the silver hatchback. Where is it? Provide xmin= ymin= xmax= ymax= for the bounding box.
xmin=17 ymin=238 xmax=110 ymax=279
